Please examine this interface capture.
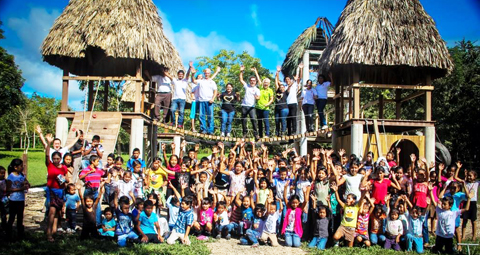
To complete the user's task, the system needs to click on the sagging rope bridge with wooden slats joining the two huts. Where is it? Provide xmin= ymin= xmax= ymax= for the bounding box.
xmin=153 ymin=121 xmax=332 ymax=143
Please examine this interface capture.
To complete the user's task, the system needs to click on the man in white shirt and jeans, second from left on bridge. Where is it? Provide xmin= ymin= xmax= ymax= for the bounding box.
xmin=165 ymin=63 xmax=190 ymax=128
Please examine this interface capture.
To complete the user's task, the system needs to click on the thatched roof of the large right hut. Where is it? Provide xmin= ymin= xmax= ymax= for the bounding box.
xmin=319 ymin=0 xmax=453 ymax=79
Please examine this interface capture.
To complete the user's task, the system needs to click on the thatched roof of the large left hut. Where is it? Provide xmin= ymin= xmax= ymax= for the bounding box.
xmin=42 ymin=0 xmax=182 ymax=76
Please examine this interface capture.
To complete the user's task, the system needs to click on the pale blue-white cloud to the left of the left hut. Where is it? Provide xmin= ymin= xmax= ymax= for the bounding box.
xmin=7 ymin=8 xmax=84 ymax=110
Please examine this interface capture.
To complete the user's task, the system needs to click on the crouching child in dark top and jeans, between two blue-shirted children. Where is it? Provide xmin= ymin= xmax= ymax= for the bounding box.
xmin=115 ymin=196 xmax=138 ymax=247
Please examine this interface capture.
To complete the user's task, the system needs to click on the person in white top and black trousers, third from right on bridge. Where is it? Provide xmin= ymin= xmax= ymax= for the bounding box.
xmin=285 ymin=63 xmax=303 ymax=135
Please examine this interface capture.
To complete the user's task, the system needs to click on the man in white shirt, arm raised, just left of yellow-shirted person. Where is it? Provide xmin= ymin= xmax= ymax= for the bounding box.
xmin=240 ymin=65 xmax=260 ymax=140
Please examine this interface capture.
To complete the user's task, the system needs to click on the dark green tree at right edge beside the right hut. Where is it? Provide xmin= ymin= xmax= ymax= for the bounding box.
xmin=433 ymin=40 xmax=480 ymax=169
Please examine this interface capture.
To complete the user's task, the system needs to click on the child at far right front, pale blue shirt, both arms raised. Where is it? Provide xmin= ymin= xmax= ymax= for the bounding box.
xmin=429 ymin=186 xmax=473 ymax=254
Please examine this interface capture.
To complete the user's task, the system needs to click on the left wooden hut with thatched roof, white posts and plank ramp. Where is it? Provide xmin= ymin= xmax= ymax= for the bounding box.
xmin=41 ymin=0 xmax=183 ymax=163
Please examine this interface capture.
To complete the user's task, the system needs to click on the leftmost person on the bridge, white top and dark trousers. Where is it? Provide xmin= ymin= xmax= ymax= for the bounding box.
xmin=145 ymin=67 xmax=172 ymax=123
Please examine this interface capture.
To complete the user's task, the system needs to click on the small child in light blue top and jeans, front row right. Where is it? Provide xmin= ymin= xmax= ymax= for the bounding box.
xmin=407 ymin=206 xmax=427 ymax=253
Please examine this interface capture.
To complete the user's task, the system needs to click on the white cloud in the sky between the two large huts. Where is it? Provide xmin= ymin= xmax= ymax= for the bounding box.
xmin=158 ymin=9 xmax=255 ymax=65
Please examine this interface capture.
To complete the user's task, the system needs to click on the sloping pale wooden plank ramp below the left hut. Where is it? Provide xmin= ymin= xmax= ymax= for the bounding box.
xmin=66 ymin=112 xmax=122 ymax=163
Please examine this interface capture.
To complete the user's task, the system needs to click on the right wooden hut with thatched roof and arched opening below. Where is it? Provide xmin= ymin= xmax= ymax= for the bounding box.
xmin=319 ymin=0 xmax=453 ymax=166
